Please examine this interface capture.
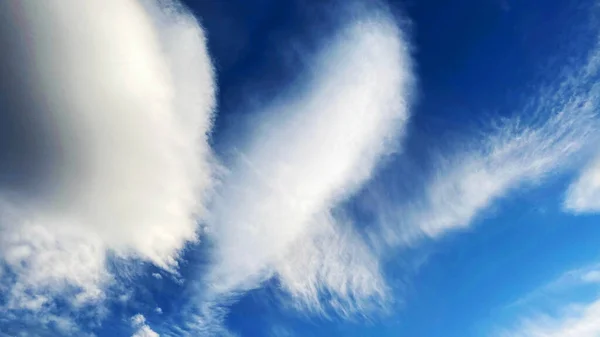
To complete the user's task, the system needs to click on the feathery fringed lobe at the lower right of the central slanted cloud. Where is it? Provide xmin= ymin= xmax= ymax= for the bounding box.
xmin=275 ymin=213 xmax=391 ymax=317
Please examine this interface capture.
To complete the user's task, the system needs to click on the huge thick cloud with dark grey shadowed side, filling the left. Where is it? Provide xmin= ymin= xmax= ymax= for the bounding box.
xmin=0 ymin=0 xmax=214 ymax=318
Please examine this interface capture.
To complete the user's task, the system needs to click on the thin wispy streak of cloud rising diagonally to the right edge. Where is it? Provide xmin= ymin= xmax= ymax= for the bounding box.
xmin=376 ymin=36 xmax=600 ymax=246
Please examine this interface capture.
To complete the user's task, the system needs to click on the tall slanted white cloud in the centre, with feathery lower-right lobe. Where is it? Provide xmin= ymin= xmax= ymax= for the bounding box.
xmin=206 ymin=6 xmax=412 ymax=315
